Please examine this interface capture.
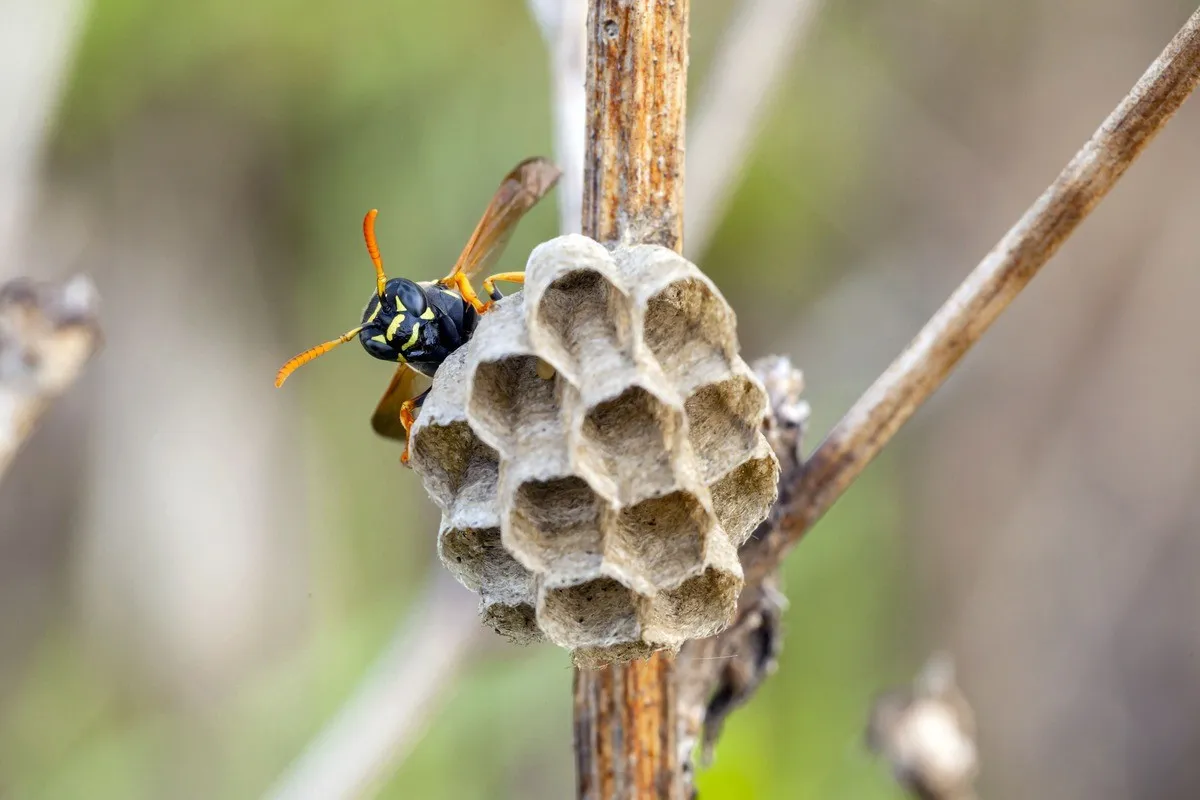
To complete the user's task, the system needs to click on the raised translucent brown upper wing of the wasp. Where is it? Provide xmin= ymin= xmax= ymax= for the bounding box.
xmin=442 ymin=156 xmax=563 ymax=283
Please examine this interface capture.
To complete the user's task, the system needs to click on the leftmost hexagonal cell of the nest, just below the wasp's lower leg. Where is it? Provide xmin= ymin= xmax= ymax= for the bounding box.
xmin=413 ymin=420 xmax=499 ymax=510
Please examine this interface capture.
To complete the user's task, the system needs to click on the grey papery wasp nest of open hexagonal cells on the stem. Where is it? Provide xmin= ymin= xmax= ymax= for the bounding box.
xmin=412 ymin=235 xmax=779 ymax=666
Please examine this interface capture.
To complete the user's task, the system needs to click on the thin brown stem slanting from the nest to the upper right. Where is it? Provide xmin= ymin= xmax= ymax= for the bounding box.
xmin=772 ymin=10 xmax=1200 ymax=566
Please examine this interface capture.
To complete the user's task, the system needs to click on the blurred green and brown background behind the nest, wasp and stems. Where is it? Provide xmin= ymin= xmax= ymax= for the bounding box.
xmin=0 ymin=0 xmax=1200 ymax=800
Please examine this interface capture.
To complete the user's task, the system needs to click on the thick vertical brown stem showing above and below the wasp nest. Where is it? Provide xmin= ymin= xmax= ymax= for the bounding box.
xmin=575 ymin=0 xmax=688 ymax=800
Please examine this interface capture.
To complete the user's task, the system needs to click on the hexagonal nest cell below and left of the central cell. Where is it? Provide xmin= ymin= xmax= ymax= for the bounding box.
xmin=504 ymin=475 xmax=612 ymax=581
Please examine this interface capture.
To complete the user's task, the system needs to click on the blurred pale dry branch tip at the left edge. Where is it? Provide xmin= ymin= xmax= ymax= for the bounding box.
xmin=0 ymin=277 xmax=100 ymax=479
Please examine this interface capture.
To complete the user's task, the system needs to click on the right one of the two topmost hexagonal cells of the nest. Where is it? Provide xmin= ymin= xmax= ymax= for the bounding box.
xmin=642 ymin=278 xmax=736 ymax=395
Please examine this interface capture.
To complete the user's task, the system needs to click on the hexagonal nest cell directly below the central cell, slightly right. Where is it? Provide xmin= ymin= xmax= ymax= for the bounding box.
xmin=605 ymin=492 xmax=713 ymax=594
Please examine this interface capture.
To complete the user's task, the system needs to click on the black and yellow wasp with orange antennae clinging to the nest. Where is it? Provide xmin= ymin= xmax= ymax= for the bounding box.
xmin=275 ymin=157 xmax=562 ymax=465
